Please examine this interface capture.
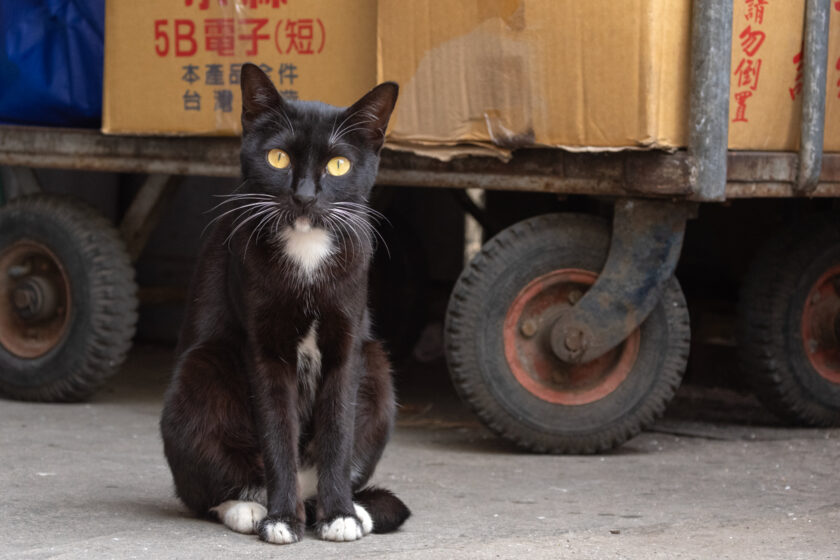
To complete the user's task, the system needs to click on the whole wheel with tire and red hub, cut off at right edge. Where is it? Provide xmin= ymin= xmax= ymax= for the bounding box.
xmin=738 ymin=215 xmax=840 ymax=426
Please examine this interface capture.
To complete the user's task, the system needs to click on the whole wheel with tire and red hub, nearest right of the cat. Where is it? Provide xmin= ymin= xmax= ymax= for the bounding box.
xmin=446 ymin=214 xmax=689 ymax=453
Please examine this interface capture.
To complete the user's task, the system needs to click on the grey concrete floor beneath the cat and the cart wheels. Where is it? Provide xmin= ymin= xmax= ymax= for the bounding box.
xmin=0 ymin=347 xmax=840 ymax=560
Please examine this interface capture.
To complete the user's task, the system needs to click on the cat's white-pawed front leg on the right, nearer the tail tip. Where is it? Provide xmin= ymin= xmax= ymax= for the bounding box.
xmin=314 ymin=341 xmax=360 ymax=541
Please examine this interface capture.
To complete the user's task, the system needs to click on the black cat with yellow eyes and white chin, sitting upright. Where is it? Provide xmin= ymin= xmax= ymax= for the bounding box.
xmin=161 ymin=64 xmax=410 ymax=543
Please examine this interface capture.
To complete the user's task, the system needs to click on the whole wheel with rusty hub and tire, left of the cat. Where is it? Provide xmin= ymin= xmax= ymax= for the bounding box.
xmin=0 ymin=195 xmax=137 ymax=401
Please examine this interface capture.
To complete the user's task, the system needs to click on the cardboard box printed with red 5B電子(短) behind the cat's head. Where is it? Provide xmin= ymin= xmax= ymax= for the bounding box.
xmin=102 ymin=0 xmax=376 ymax=135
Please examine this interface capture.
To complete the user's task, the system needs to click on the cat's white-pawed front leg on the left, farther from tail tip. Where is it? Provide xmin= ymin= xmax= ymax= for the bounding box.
xmin=253 ymin=358 xmax=305 ymax=544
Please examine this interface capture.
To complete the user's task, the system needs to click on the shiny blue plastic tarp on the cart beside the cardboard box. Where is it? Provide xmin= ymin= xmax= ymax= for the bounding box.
xmin=0 ymin=0 xmax=105 ymax=128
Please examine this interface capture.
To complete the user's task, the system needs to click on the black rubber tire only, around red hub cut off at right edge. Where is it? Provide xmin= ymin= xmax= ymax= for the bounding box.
xmin=738 ymin=214 xmax=840 ymax=426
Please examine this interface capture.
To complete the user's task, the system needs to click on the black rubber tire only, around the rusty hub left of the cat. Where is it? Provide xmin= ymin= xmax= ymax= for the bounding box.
xmin=0 ymin=194 xmax=137 ymax=402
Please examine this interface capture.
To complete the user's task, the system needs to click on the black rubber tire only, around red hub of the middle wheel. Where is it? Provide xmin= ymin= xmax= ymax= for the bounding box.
xmin=445 ymin=214 xmax=690 ymax=453
